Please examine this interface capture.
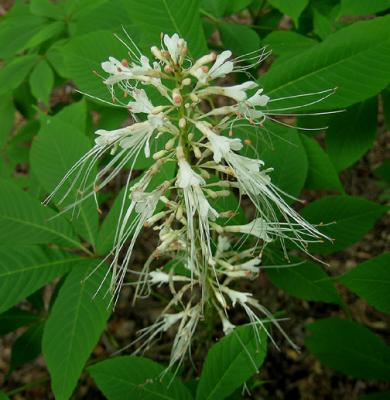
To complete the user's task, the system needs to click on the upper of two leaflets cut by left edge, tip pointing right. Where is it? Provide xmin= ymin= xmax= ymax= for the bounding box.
xmin=0 ymin=179 xmax=82 ymax=248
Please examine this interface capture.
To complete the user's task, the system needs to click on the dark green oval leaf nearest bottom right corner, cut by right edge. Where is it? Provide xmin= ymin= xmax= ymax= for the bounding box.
xmin=305 ymin=318 xmax=390 ymax=380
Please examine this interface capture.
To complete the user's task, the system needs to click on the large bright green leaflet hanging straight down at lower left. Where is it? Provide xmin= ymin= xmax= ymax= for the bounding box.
xmin=42 ymin=260 xmax=110 ymax=400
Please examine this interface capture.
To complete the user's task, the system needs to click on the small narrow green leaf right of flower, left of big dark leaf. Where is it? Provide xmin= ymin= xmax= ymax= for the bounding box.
xmin=301 ymin=135 xmax=344 ymax=193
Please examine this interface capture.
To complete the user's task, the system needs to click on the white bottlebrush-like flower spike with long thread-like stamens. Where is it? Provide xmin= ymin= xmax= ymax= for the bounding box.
xmin=48 ymin=34 xmax=331 ymax=365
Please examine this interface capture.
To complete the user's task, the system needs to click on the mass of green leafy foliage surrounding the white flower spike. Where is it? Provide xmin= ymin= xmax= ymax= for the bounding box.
xmin=0 ymin=0 xmax=390 ymax=400
